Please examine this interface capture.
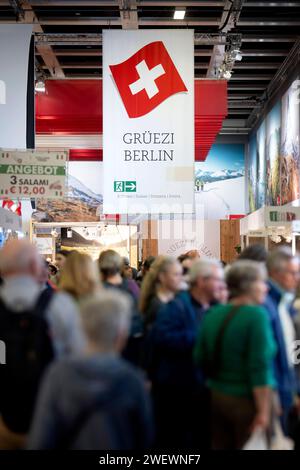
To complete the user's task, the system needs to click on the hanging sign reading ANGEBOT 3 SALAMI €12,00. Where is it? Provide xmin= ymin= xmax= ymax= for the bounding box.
xmin=0 ymin=151 xmax=68 ymax=199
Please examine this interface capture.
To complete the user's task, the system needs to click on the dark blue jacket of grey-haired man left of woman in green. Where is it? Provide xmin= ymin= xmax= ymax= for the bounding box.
xmin=151 ymin=292 xmax=205 ymax=388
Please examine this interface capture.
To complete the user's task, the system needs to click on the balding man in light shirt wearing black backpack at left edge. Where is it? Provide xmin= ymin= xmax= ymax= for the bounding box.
xmin=0 ymin=240 xmax=83 ymax=448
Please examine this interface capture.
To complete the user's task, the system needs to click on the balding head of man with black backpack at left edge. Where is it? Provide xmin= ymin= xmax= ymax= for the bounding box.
xmin=0 ymin=239 xmax=42 ymax=279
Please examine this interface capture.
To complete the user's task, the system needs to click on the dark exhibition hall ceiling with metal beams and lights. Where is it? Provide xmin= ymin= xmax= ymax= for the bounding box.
xmin=0 ymin=0 xmax=300 ymax=133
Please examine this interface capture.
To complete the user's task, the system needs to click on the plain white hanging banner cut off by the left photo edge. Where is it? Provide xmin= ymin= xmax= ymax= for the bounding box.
xmin=0 ymin=24 xmax=32 ymax=149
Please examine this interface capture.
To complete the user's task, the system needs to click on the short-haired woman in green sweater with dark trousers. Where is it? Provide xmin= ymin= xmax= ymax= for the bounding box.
xmin=195 ymin=260 xmax=276 ymax=449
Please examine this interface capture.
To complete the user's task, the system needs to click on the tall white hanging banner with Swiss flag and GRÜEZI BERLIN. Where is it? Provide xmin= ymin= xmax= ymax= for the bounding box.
xmin=103 ymin=30 xmax=194 ymax=214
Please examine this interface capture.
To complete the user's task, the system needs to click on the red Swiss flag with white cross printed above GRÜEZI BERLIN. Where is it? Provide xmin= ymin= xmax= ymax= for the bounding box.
xmin=109 ymin=41 xmax=188 ymax=118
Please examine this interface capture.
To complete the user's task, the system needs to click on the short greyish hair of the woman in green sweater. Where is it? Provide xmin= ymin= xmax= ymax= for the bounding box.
xmin=225 ymin=259 xmax=267 ymax=299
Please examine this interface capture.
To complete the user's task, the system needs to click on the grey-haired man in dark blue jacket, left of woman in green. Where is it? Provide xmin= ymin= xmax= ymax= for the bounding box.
xmin=152 ymin=260 xmax=224 ymax=449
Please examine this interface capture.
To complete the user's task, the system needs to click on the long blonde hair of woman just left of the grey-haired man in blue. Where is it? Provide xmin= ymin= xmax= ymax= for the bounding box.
xmin=139 ymin=256 xmax=178 ymax=313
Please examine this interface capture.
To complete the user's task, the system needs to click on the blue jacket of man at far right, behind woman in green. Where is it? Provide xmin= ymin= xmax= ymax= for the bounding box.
xmin=264 ymin=282 xmax=297 ymax=410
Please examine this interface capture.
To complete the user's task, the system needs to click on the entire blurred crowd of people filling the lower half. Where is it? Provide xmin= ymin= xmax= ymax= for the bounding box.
xmin=0 ymin=240 xmax=300 ymax=451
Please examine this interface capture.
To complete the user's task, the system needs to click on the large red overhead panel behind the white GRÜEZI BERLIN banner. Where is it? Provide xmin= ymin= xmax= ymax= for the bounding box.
xmin=36 ymin=80 xmax=227 ymax=161
